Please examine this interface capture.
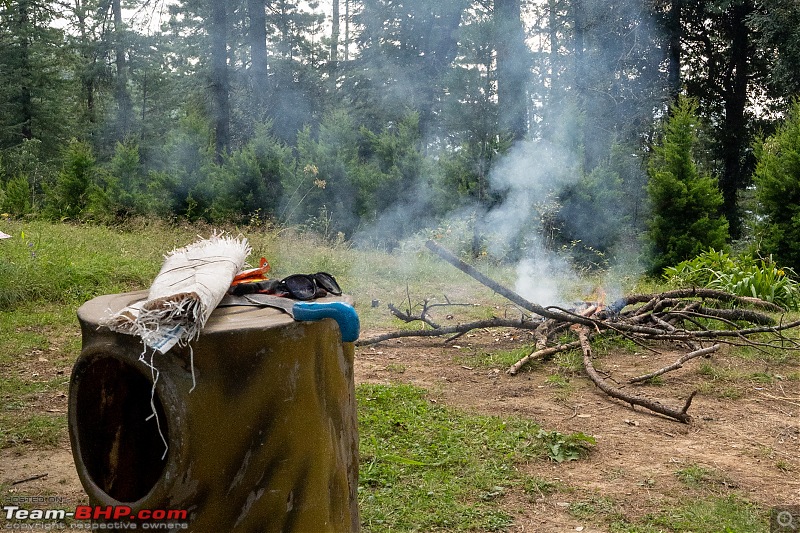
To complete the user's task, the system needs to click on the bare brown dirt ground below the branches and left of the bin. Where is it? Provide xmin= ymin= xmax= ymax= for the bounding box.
xmin=0 ymin=330 xmax=800 ymax=533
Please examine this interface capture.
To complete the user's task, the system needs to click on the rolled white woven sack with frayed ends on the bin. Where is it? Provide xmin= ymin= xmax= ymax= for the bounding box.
xmin=101 ymin=234 xmax=250 ymax=353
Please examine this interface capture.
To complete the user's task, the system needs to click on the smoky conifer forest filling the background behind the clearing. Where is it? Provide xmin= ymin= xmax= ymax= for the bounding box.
xmin=0 ymin=0 xmax=800 ymax=273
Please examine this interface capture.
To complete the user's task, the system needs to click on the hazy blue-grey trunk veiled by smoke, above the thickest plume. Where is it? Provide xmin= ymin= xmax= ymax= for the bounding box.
xmin=494 ymin=0 xmax=529 ymax=140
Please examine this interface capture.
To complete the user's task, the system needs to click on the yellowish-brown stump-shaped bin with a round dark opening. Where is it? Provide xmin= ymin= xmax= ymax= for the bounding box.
xmin=68 ymin=292 xmax=359 ymax=533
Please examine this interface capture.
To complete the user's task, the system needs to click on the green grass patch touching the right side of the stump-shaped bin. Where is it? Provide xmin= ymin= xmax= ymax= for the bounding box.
xmin=357 ymin=384 xmax=592 ymax=532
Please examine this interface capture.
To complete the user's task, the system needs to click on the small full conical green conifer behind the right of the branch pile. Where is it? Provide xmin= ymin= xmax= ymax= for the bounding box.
xmin=647 ymin=98 xmax=728 ymax=273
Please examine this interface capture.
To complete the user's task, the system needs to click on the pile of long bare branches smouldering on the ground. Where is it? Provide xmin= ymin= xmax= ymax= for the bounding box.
xmin=357 ymin=241 xmax=800 ymax=423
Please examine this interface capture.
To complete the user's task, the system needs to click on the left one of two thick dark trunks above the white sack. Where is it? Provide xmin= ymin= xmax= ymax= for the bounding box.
xmin=210 ymin=0 xmax=230 ymax=163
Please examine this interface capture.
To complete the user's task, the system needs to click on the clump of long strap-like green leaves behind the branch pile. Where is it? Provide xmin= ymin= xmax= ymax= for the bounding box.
xmin=664 ymin=248 xmax=800 ymax=310
